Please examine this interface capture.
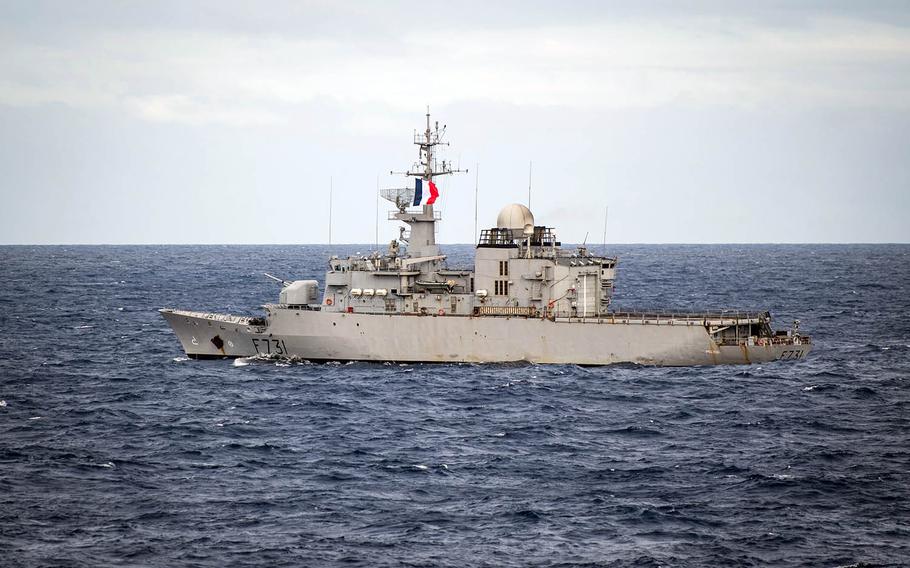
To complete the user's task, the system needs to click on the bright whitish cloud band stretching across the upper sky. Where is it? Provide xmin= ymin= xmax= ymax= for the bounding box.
xmin=0 ymin=8 xmax=910 ymax=126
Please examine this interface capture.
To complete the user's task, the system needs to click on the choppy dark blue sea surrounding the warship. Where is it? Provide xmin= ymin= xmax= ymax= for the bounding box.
xmin=0 ymin=245 xmax=910 ymax=567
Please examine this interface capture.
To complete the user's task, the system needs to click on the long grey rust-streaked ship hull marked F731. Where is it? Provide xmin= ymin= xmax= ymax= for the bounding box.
xmin=161 ymin=310 xmax=811 ymax=366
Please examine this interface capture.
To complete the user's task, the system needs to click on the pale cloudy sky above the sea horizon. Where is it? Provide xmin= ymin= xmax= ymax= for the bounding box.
xmin=0 ymin=0 xmax=910 ymax=244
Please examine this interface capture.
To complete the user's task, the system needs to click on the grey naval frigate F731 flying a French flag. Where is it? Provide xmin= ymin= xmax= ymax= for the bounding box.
xmin=161 ymin=113 xmax=812 ymax=366
